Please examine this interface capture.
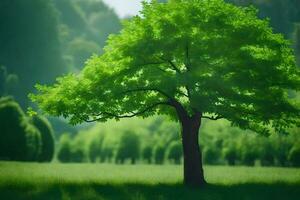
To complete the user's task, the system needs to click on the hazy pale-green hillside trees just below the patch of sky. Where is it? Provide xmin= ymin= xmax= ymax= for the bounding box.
xmin=54 ymin=0 xmax=120 ymax=70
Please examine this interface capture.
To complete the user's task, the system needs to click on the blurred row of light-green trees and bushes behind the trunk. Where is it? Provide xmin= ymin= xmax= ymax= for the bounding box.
xmin=57 ymin=116 xmax=300 ymax=167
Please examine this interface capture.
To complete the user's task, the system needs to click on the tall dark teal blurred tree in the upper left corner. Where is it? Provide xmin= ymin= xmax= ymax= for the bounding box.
xmin=0 ymin=0 xmax=66 ymax=108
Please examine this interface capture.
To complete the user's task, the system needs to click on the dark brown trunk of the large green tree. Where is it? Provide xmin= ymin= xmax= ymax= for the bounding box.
xmin=180 ymin=113 xmax=206 ymax=186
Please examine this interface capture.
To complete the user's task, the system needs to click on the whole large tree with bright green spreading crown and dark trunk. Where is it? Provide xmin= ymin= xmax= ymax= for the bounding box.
xmin=31 ymin=0 xmax=300 ymax=185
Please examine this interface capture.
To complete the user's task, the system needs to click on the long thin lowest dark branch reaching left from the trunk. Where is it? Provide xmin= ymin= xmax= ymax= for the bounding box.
xmin=84 ymin=102 xmax=171 ymax=122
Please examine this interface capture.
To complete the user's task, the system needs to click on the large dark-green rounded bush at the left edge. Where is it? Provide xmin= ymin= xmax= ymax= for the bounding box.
xmin=0 ymin=97 xmax=41 ymax=161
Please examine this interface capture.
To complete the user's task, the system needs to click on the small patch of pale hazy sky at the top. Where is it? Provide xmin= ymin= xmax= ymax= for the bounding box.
xmin=103 ymin=0 xmax=146 ymax=17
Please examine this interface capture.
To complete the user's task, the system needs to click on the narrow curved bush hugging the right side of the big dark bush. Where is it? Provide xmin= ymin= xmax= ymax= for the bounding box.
xmin=31 ymin=116 xmax=55 ymax=162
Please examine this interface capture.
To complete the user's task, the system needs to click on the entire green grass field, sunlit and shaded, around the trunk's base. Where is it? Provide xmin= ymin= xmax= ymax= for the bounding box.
xmin=0 ymin=162 xmax=300 ymax=200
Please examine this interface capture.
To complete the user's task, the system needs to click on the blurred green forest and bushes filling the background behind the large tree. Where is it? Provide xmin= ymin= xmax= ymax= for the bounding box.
xmin=0 ymin=0 xmax=300 ymax=166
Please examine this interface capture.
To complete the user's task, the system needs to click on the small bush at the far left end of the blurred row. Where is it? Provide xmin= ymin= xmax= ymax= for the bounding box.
xmin=57 ymin=133 xmax=71 ymax=162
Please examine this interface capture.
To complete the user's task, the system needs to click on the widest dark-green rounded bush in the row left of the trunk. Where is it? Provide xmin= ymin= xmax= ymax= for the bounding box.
xmin=116 ymin=131 xmax=140 ymax=164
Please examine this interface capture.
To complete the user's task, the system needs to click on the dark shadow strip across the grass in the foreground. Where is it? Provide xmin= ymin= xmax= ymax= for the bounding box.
xmin=0 ymin=183 xmax=300 ymax=200
